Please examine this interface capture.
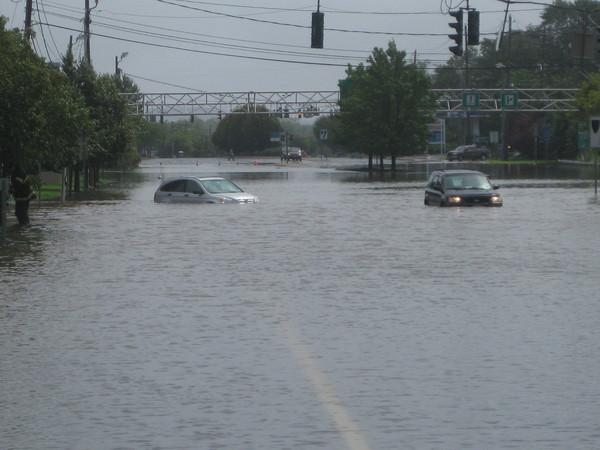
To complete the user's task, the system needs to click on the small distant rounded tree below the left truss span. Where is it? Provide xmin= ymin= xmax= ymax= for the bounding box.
xmin=212 ymin=106 xmax=281 ymax=155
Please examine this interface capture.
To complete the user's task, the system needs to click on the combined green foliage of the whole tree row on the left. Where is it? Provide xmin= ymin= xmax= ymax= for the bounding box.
xmin=0 ymin=18 xmax=139 ymax=180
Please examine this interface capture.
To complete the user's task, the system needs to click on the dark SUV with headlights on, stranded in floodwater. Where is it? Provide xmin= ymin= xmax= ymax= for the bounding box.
xmin=425 ymin=170 xmax=503 ymax=206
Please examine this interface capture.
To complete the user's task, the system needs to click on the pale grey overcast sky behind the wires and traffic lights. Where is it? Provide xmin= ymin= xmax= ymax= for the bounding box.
xmin=0 ymin=0 xmax=551 ymax=93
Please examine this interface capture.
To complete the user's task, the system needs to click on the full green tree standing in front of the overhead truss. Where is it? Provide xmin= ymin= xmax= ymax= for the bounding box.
xmin=340 ymin=41 xmax=435 ymax=170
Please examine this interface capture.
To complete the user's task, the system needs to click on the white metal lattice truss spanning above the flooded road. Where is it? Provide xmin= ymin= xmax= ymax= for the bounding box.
xmin=123 ymin=89 xmax=578 ymax=118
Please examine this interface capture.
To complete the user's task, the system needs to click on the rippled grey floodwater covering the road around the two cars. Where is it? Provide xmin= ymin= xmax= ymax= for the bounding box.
xmin=0 ymin=160 xmax=600 ymax=450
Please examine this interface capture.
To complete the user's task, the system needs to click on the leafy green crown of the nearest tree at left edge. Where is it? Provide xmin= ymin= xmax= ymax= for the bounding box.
xmin=0 ymin=17 xmax=91 ymax=171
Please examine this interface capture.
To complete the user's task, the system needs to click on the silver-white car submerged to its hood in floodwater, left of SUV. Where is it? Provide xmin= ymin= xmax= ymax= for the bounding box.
xmin=154 ymin=177 xmax=258 ymax=203
